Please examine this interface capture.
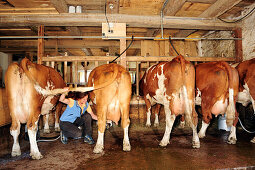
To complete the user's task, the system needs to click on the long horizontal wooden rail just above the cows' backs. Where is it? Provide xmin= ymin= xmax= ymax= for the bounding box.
xmin=42 ymin=56 xmax=236 ymax=62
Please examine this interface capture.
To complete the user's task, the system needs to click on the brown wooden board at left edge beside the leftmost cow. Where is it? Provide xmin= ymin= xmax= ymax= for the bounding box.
xmin=0 ymin=88 xmax=11 ymax=127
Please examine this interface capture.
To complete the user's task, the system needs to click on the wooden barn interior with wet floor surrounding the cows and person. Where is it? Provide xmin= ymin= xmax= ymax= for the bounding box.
xmin=0 ymin=0 xmax=255 ymax=169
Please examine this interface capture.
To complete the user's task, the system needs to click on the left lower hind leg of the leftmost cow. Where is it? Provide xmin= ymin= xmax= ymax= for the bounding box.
xmin=10 ymin=121 xmax=21 ymax=156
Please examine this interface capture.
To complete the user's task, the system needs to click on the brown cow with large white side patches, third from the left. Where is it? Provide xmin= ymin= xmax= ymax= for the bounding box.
xmin=138 ymin=55 xmax=200 ymax=148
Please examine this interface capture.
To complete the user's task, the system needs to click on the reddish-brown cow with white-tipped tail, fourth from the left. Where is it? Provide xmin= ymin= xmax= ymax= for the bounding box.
xmin=195 ymin=62 xmax=239 ymax=144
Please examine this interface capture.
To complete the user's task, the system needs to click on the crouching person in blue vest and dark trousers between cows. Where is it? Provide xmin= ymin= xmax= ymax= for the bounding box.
xmin=59 ymin=89 xmax=97 ymax=144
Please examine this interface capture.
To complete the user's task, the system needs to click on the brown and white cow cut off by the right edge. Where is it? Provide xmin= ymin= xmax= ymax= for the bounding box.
xmin=236 ymin=58 xmax=255 ymax=143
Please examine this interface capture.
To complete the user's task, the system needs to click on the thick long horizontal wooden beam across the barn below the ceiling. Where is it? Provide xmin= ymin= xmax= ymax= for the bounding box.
xmin=0 ymin=13 xmax=239 ymax=30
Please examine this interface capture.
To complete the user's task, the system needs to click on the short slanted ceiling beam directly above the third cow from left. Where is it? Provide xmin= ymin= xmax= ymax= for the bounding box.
xmin=163 ymin=0 xmax=186 ymax=16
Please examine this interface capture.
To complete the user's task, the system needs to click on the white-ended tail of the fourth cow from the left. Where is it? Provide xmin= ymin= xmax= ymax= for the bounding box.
xmin=221 ymin=62 xmax=236 ymax=126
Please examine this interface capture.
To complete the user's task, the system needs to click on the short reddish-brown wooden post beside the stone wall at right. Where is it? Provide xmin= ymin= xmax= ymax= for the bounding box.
xmin=234 ymin=28 xmax=243 ymax=62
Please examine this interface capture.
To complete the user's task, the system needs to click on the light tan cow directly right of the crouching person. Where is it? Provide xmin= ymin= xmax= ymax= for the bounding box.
xmin=88 ymin=63 xmax=131 ymax=153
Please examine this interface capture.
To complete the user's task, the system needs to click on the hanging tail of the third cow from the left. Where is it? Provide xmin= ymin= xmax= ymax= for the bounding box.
xmin=177 ymin=55 xmax=193 ymax=127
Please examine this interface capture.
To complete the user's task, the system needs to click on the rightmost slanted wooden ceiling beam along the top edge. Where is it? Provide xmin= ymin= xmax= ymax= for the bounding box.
xmin=199 ymin=0 xmax=242 ymax=18
